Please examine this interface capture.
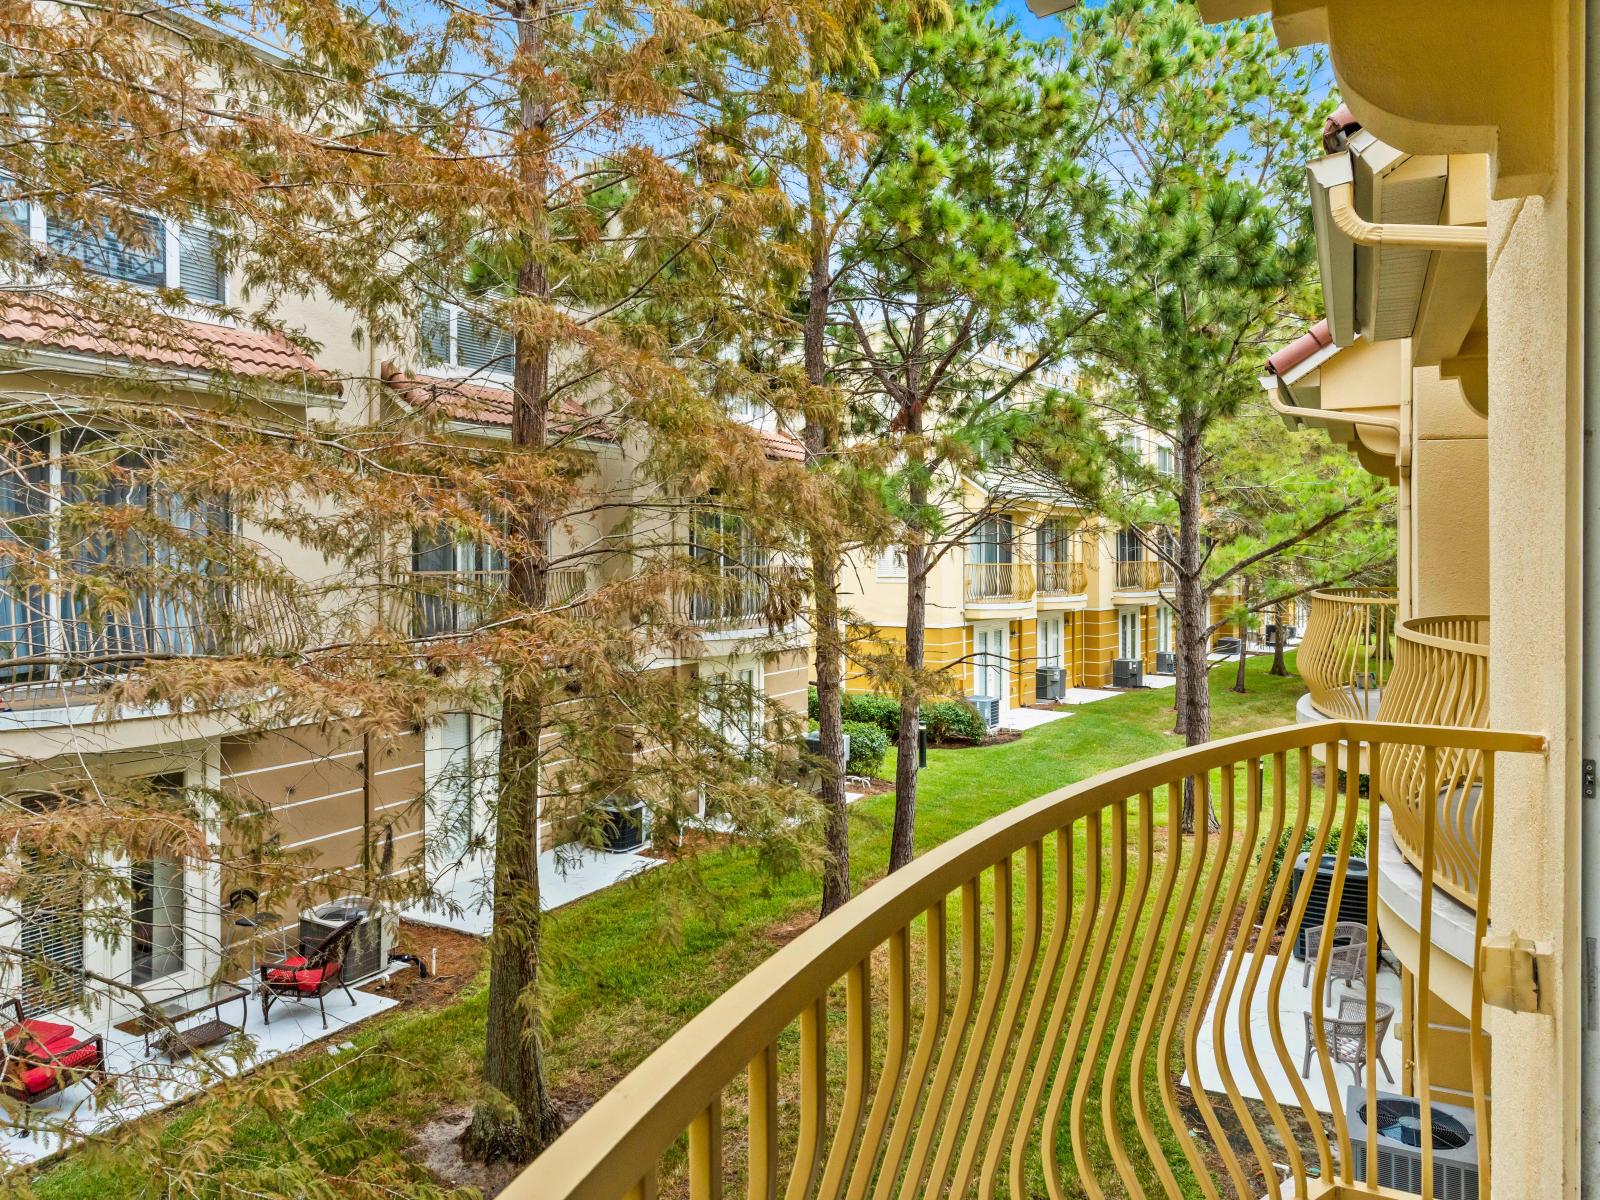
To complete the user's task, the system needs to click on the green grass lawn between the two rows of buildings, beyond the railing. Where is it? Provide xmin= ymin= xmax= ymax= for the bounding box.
xmin=32 ymin=658 xmax=1302 ymax=1200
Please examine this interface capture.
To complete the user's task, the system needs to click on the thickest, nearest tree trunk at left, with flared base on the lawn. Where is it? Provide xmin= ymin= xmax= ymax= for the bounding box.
xmin=461 ymin=0 xmax=562 ymax=1163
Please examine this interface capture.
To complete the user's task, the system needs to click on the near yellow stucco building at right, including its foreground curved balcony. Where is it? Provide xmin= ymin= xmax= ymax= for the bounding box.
xmin=534 ymin=0 xmax=1600 ymax=1200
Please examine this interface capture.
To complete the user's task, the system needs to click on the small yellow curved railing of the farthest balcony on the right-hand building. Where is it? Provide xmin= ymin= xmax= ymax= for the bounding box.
xmin=1296 ymin=587 xmax=1398 ymax=720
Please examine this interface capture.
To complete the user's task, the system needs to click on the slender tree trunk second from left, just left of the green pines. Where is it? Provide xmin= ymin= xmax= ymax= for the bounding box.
xmin=803 ymin=126 xmax=850 ymax=917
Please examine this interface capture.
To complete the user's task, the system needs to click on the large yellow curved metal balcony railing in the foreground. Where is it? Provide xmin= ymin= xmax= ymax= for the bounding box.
xmin=521 ymin=722 xmax=1544 ymax=1200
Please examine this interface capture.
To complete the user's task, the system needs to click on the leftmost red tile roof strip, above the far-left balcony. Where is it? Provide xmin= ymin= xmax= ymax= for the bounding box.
xmin=0 ymin=294 xmax=339 ymax=392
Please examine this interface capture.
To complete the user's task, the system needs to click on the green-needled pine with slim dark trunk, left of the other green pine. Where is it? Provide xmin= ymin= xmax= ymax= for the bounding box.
xmin=838 ymin=5 xmax=1102 ymax=870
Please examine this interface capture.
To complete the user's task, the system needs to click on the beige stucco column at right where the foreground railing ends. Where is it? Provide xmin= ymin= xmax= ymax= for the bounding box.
xmin=1488 ymin=10 xmax=1582 ymax=1200
